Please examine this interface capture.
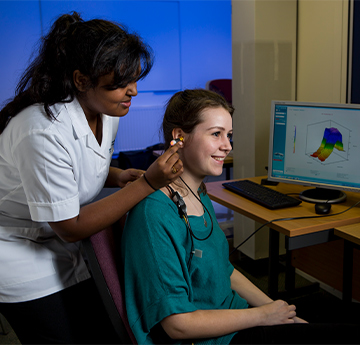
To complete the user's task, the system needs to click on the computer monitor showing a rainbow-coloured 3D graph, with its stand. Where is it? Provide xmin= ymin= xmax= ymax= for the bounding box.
xmin=268 ymin=101 xmax=360 ymax=203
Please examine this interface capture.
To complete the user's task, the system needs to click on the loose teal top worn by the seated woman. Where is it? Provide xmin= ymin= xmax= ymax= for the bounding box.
xmin=121 ymin=191 xmax=248 ymax=344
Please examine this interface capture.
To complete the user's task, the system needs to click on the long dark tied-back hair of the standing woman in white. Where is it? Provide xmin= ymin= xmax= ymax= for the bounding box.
xmin=0 ymin=12 xmax=153 ymax=134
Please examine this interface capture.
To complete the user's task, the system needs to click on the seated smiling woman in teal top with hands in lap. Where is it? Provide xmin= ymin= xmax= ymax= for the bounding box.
xmin=122 ymin=90 xmax=356 ymax=344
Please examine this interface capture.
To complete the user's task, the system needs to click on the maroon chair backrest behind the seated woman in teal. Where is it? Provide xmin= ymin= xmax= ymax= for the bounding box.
xmin=82 ymin=216 xmax=136 ymax=344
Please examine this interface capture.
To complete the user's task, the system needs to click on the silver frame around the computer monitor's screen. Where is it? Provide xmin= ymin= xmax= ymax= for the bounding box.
xmin=268 ymin=100 xmax=360 ymax=198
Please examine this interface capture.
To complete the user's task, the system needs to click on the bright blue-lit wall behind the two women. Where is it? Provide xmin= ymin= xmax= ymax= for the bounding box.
xmin=0 ymin=0 xmax=232 ymax=152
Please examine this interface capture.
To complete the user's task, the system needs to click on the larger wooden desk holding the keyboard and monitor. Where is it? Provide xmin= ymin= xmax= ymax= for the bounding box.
xmin=206 ymin=176 xmax=360 ymax=298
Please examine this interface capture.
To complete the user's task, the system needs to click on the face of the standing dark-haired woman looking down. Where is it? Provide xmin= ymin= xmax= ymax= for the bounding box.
xmin=79 ymin=70 xmax=137 ymax=120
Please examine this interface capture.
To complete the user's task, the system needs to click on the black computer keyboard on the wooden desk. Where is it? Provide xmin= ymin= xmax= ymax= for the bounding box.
xmin=223 ymin=180 xmax=301 ymax=210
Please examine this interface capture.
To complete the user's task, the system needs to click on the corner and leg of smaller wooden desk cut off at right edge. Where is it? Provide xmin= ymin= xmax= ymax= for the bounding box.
xmin=334 ymin=223 xmax=360 ymax=303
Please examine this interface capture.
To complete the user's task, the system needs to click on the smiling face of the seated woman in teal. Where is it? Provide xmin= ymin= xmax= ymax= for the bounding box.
xmin=180 ymin=107 xmax=232 ymax=181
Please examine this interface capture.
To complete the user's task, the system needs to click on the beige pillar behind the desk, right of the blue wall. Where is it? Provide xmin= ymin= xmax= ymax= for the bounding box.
xmin=232 ymin=0 xmax=297 ymax=259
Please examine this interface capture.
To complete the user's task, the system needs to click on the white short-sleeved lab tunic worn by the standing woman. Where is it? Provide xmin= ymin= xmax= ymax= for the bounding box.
xmin=0 ymin=99 xmax=119 ymax=302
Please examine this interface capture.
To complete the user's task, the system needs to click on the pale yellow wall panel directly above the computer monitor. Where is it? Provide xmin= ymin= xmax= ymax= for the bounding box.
xmin=296 ymin=0 xmax=349 ymax=103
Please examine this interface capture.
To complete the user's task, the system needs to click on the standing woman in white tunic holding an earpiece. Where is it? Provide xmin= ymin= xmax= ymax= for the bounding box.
xmin=0 ymin=13 xmax=182 ymax=344
